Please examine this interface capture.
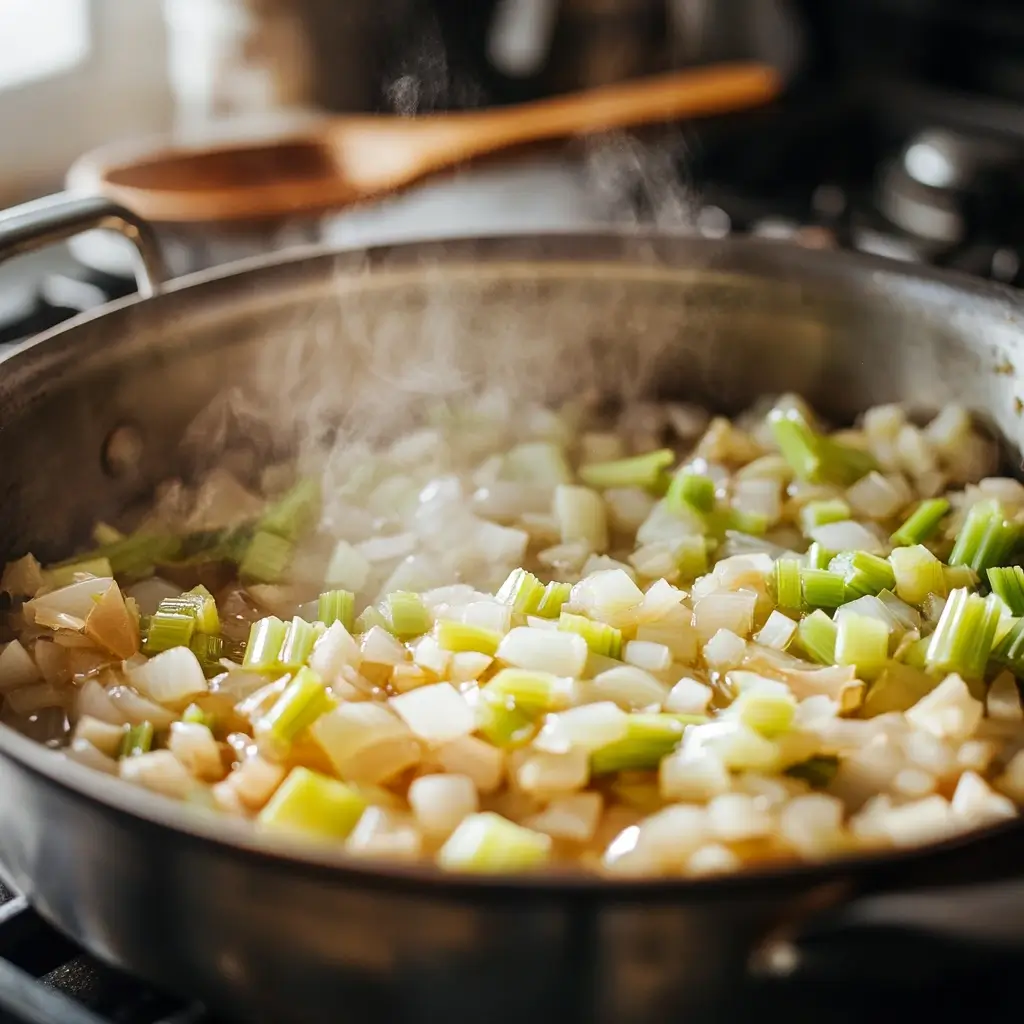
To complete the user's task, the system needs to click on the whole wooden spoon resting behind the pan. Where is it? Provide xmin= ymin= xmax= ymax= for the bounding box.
xmin=87 ymin=63 xmax=780 ymax=223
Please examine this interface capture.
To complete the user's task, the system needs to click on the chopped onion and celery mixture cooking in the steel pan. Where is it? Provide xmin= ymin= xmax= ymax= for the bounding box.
xmin=0 ymin=396 xmax=1024 ymax=876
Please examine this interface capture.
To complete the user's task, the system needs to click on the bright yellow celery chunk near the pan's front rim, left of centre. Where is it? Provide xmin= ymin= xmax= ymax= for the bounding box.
xmin=257 ymin=768 xmax=367 ymax=840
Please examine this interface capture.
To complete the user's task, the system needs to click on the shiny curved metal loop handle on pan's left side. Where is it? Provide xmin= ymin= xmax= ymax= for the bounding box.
xmin=0 ymin=193 xmax=167 ymax=298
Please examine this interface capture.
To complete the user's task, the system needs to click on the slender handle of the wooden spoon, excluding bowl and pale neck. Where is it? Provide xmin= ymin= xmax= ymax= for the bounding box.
xmin=424 ymin=63 xmax=781 ymax=159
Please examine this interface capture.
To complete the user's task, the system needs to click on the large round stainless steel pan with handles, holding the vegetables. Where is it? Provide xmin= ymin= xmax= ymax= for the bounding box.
xmin=0 ymin=193 xmax=1024 ymax=1024
